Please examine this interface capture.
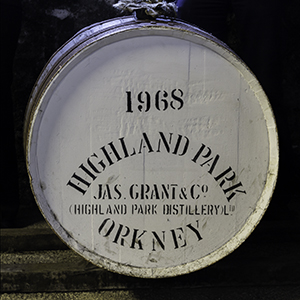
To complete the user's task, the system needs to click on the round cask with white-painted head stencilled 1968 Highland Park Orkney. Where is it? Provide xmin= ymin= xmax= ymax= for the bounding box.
xmin=25 ymin=17 xmax=278 ymax=278
